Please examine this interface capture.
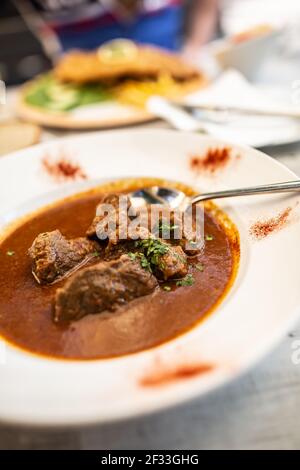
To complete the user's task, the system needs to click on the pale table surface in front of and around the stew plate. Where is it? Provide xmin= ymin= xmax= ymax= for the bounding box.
xmin=0 ymin=86 xmax=300 ymax=450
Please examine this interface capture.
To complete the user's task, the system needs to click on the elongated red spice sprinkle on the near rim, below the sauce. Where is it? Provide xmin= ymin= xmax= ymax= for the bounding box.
xmin=140 ymin=364 xmax=214 ymax=387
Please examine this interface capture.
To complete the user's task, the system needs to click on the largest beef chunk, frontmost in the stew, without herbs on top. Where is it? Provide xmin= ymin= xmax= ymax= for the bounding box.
xmin=54 ymin=255 xmax=157 ymax=322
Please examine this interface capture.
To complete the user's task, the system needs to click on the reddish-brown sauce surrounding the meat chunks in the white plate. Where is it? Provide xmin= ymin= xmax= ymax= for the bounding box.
xmin=0 ymin=179 xmax=239 ymax=360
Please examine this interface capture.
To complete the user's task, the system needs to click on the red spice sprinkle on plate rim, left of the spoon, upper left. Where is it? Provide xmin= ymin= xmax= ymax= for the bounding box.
xmin=42 ymin=156 xmax=87 ymax=181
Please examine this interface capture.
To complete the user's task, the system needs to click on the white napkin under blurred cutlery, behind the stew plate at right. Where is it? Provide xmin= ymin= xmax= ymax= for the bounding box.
xmin=186 ymin=70 xmax=300 ymax=147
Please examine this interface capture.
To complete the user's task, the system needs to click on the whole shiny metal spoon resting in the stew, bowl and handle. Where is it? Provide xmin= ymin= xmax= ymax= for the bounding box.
xmin=129 ymin=180 xmax=300 ymax=210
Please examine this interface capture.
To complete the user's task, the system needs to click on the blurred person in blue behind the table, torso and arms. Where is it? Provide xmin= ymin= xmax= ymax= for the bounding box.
xmin=15 ymin=0 xmax=218 ymax=59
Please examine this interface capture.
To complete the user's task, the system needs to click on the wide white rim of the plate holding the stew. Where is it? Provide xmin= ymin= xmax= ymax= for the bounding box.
xmin=0 ymin=130 xmax=300 ymax=426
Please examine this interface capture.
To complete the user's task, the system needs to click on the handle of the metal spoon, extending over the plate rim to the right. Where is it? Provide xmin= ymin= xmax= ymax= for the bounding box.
xmin=190 ymin=180 xmax=300 ymax=204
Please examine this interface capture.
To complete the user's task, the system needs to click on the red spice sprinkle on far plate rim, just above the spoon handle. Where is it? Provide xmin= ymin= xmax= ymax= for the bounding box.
xmin=190 ymin=147 xmax=231 ymax=173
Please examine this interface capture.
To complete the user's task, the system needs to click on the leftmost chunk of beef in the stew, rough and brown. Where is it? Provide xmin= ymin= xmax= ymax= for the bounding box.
xmin=28 ymin=230 xmax=101 ymax=284
